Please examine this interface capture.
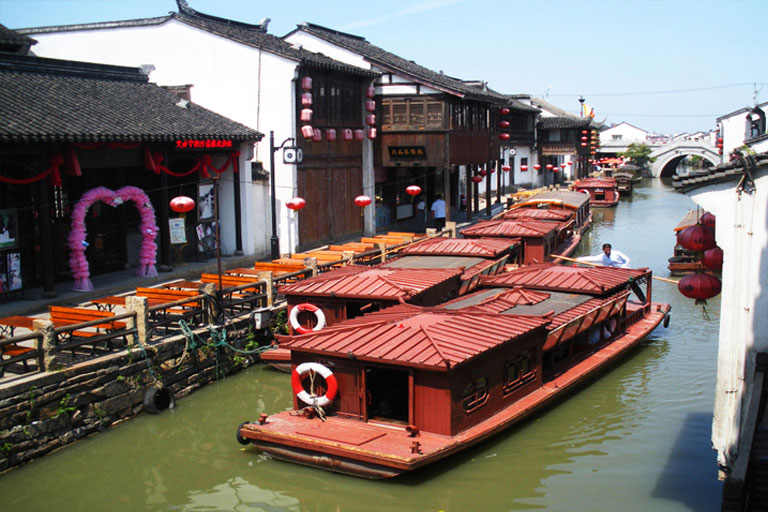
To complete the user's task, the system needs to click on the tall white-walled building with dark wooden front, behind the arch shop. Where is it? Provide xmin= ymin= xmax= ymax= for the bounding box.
xmin=24 ymin=0 xmax=375 ymax=257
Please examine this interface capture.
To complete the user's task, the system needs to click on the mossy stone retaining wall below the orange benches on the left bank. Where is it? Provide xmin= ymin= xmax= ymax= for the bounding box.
xmin=0 ymin=320 xmax=263 ymax=471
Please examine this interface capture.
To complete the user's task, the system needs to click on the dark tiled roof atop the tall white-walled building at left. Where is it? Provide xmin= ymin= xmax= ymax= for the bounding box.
xmin=19 ymin=9 xmax=378 ymax=78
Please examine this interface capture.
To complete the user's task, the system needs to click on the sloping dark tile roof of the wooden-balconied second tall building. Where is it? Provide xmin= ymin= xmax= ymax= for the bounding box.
xmin=284 ymin=22 xmax=508 ymax=104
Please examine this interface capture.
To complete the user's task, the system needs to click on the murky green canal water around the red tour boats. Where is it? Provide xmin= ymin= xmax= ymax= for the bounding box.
xmin=0 ymin=179 xmax=721 ymax=512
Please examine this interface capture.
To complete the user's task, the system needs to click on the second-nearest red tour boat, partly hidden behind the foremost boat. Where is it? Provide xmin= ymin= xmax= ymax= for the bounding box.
xmin=261 ymin=237 xmax=521 ymax=371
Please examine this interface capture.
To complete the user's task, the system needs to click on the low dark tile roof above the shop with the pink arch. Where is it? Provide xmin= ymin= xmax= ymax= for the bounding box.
xmin=0 ymin=53 xmax=263 ymax=143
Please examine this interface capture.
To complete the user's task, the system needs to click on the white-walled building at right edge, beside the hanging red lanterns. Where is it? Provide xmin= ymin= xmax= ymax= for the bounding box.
xmin=674 ymin=155 xmax=768 ymax=510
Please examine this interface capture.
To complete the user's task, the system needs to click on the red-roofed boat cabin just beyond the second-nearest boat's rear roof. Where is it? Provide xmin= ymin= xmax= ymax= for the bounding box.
xmin=461 ymin=219 xmax=563 ymax=265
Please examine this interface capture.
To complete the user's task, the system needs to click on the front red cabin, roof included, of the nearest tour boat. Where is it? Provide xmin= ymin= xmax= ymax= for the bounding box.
xmin=285 ymin=306 xmax=548 ymax=436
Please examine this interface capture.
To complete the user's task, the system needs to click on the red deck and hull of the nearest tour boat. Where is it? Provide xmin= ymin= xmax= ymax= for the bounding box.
xmin=238 ymin=303 xmax=670 ymax=479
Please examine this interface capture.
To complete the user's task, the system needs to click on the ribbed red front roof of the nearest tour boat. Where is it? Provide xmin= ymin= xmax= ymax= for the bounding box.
xmin=281 ymin=308 xmax=548 ymax=370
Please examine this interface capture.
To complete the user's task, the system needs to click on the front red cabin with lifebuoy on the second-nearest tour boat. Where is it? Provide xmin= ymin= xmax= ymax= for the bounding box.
xmin=279 ymin=266 xmax=464 ymax=334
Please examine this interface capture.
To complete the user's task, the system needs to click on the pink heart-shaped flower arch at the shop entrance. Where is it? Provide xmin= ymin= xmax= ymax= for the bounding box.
xmin=68 ymin=186 xmax=158 ymax=292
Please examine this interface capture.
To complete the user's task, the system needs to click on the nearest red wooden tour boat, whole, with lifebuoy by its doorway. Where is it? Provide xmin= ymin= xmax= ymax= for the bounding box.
xmin=237 ymin=264 xmax=670 ymax=478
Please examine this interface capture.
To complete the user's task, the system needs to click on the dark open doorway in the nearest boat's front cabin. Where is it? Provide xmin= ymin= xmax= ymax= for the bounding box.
xmin=365 ymin=367 xmax=410 ymax=423
